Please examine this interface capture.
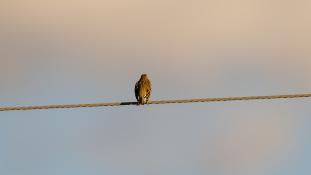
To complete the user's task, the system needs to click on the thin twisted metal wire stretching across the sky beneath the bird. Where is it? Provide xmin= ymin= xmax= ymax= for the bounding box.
xmin=0 ymin=94 xmax=311 ymax=111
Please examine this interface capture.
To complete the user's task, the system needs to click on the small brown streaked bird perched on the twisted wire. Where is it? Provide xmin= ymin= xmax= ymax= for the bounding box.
xmin=135 ymin=74 xmax=151 ymax=105
